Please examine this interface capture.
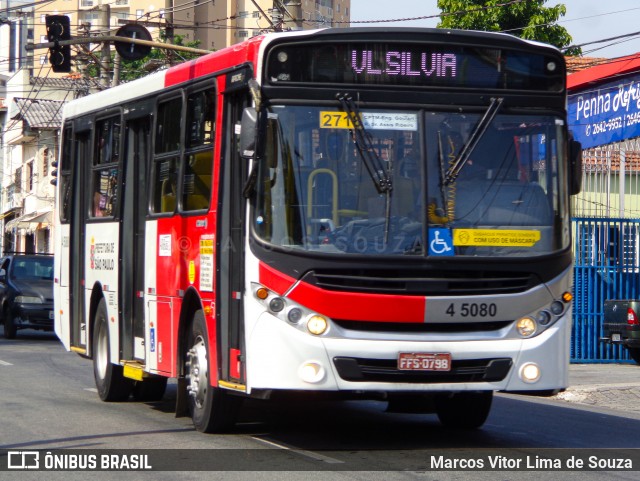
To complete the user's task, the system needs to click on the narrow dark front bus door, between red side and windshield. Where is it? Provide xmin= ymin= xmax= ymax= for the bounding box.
xmin=216 ymin=68 xmax=250 ymax=384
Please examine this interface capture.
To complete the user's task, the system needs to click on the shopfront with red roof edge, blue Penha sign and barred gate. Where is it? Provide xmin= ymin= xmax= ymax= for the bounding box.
xmin=567 ymin=55 xmax=640 ymax=362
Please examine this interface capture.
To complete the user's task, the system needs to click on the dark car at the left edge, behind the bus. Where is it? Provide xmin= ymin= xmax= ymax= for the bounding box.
xmin=0 ymin=254 xmax=53 ymax=339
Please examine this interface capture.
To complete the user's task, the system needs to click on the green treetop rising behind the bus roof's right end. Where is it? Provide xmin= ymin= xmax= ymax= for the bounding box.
xmin=438 ymin=0 xmax=581 ymax=55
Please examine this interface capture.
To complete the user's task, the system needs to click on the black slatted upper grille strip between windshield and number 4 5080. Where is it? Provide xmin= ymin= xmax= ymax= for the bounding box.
xmin=304 ymin=270 xmax=539 ymax=296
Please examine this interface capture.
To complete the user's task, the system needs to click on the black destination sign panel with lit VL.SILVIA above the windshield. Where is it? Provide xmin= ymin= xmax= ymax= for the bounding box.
xmin=266 ymin=42 xmax=565 ymax=92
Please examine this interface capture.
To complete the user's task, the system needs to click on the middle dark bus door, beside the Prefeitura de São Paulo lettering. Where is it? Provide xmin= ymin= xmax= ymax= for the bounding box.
xmin=118 ymin=112 xmax=151 ymax=361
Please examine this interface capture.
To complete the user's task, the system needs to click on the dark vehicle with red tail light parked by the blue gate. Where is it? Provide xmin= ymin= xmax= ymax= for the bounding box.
xmin=600 ymin=299 xmax=640 ymax=364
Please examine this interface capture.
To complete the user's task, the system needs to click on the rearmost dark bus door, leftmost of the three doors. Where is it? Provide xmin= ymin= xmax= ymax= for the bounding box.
xmin=68 ymin=126 xmax=91 ymax=353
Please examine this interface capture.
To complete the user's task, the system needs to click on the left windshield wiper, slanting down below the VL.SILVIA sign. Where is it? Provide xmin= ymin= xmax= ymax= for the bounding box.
xmin=336 ymin=94 xmax=392 ymax=194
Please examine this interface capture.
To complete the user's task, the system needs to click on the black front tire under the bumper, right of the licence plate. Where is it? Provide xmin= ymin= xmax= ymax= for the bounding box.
xmin=435 ymin=391 xmax=493 ymax=429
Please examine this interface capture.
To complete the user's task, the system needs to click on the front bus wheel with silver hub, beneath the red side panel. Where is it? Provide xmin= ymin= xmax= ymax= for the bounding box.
xmin=185 ymin=310 xmax=241 ymax=433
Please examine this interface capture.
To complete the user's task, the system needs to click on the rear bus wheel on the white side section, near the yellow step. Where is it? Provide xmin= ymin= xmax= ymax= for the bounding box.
xmin=92 ymin=299 xmax=133 ymax=402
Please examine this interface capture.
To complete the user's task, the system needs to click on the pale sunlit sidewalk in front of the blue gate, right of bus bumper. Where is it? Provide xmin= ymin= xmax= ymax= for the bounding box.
xmin=552 ymin=364 xmax=640 ymax=412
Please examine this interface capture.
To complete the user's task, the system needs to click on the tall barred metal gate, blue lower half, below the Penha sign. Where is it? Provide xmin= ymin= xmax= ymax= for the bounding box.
xmin=571 ymin=141 xmax=640 ymax=363
